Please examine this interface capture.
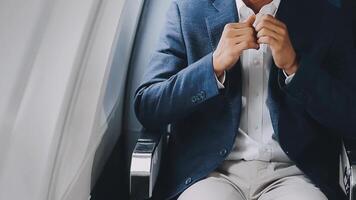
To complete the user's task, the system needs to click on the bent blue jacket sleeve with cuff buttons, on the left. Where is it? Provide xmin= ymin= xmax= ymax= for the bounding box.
xmin=134 ymin=1 xmax=219 ymax=128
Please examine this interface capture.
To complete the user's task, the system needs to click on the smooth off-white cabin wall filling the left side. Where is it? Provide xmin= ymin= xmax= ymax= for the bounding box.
xmin=0 ymin=0 xmax=126 ymax=200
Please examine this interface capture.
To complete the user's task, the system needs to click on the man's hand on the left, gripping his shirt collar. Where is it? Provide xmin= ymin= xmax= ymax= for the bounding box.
xmin=213 ymin=15 xmax=259 ymax=77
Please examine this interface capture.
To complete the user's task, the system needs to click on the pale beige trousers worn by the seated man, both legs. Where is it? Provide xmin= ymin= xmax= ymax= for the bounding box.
xmin=178 ymin=160 xmax=327 ymax=200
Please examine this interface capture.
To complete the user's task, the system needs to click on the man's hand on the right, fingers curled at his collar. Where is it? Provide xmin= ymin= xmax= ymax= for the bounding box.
xmin=256 ymin=15 xmax=298 ymax=75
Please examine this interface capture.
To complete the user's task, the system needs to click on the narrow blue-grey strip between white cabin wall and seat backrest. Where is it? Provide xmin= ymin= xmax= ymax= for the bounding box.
xmin=92 ymin=0 xmax=144 ymax=189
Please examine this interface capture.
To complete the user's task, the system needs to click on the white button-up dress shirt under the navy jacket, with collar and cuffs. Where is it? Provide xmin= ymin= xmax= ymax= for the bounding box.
xmin=217 ymin=0 xmax=294 ymax=162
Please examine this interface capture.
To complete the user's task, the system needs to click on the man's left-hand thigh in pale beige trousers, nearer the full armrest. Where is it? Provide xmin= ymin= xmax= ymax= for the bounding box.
xmin=178 ymin=173 xmax=246 ymax=200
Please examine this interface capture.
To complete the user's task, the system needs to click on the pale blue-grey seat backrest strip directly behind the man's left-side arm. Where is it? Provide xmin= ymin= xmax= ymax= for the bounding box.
xmin=124 ymin=0 xmax=171 ymax=132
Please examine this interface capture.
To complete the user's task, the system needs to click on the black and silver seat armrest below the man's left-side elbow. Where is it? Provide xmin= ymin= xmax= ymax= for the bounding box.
xmin=130 ymin=131 xmax=166 ymax=200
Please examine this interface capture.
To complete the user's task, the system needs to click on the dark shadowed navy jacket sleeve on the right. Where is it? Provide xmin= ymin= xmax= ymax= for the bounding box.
xmin=279 ymin=9 xmax=356 ymax=138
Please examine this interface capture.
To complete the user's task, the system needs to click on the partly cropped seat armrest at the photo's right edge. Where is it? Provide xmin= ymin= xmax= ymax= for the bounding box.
xmin=340 ymin=140 xmax=356 ymax=200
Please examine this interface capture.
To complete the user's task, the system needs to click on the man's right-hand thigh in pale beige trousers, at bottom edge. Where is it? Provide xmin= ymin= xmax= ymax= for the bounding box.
xmin=258 ymin=176 xmax=327 ymax=200
